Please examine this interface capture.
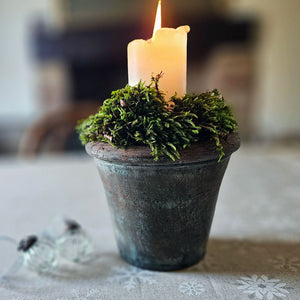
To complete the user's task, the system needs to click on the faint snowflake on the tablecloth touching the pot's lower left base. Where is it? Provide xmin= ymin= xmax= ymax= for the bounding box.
xmin=109 ymin=266 xmax=157 ymax=291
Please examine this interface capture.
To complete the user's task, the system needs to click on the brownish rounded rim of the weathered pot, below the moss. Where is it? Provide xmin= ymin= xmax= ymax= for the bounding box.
xmin=85 ymin=132 xmax=240 ymax=165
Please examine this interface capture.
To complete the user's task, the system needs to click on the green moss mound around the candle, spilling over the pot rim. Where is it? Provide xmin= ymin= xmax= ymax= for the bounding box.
xmin=77 ymin=76 xmax=237 ymax=160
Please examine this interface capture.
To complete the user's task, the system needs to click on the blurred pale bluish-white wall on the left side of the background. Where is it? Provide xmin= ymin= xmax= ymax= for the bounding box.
xmin=0 ymin=0 xmax=49 ymax=122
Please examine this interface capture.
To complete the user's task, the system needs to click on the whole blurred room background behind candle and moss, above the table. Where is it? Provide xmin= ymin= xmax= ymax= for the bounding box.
xmin=0 ymin=0 xmax=300 ymax=157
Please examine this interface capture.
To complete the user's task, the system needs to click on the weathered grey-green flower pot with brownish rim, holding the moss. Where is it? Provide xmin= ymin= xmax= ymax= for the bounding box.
xmin=86 ymin=133 xmax=240 ymax=271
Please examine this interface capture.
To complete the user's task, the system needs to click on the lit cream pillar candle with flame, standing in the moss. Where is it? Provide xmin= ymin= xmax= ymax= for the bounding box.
xmin=128 ymin=0 xmax=190 ymax=100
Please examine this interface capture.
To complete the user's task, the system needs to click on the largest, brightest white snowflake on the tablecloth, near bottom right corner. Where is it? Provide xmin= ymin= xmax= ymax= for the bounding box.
xmin=237 ymin=274 xmax=289 ymax=300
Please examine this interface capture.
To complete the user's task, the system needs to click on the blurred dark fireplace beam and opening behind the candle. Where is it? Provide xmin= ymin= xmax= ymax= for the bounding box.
xmin=34 ymin=17 xmax=253 ymax=101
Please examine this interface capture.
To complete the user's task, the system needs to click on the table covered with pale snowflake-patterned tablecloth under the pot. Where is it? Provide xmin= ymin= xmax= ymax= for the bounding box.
xmin=0 ymin=146 xmax=300 ymax=300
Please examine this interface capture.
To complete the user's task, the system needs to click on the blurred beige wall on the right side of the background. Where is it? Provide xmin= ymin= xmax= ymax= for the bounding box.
xmin=230 ymin=0 xmax=300 ymax=138
